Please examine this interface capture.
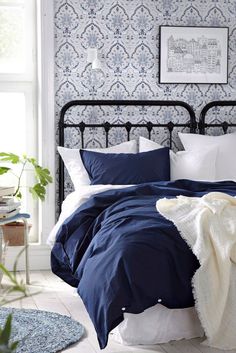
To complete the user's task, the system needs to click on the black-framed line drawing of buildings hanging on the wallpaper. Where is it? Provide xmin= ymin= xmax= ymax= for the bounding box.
xmin=159 ymin=26 xmax=229 ymax=84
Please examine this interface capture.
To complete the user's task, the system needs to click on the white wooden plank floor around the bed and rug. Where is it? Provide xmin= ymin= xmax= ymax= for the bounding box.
xmin=3 ymin=271 xmax=236 ymax=353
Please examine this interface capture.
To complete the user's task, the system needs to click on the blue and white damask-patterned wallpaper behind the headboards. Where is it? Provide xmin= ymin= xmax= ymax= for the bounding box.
xmin=54 ymin=0 xmax=236 ymax=195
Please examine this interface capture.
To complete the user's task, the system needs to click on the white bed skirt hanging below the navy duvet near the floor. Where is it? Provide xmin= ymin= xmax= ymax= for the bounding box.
xmin=110 ymin=304 xmax=204 ymax=345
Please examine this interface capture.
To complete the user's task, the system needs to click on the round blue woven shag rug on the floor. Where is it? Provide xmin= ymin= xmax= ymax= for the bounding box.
xmin=0 ymin=308 xmax=84 ymax=353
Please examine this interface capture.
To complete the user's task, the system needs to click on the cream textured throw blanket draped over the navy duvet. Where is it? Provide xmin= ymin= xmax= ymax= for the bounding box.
xmin=156 ymin=192 xmax=236 ymax=349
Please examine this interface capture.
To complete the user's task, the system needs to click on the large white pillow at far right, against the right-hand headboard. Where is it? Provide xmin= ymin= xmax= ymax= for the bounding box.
xmin=179 ymin=133 xmax=236 ymax=180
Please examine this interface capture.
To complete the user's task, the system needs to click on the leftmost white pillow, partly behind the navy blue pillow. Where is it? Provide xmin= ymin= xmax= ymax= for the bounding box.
xmin=57 ymin=140 xmax=137 ymax=190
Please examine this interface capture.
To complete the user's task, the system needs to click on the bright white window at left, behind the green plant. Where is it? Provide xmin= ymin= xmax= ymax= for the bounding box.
xmin=0 ymin=0 xmax=38 ymax=242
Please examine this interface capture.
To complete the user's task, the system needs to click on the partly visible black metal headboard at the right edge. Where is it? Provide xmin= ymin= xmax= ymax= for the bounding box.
xmin=198 ymin=101 xmax=236 ymax=135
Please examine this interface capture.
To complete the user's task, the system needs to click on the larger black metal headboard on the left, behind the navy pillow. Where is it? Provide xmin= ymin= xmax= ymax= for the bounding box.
xmin=59 ymin=100 xmax=197 ymax=206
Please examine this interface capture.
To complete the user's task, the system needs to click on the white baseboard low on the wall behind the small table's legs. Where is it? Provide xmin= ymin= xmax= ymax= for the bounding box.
xmin=5 ymin=245 xmax=51 ymax=271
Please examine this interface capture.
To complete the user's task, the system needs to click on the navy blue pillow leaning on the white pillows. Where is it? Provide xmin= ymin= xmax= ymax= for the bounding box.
xmin=80 ymin=147 xmax=170 ymax=185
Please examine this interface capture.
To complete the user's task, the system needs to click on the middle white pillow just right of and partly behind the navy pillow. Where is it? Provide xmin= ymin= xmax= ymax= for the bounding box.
xmin=139 ymin=136 xmax=217 ymax=181
